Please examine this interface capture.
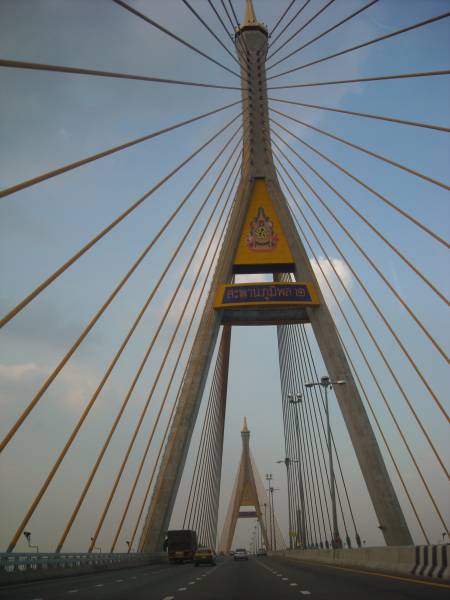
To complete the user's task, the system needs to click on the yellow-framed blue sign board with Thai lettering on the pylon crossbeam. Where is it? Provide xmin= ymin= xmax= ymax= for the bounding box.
xmin=214 ymin=282 xmax=319 ymax=308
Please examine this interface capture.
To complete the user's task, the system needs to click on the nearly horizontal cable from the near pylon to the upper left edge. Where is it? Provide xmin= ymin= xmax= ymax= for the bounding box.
xmin=0 ymin=58 xmax=241 ymax=90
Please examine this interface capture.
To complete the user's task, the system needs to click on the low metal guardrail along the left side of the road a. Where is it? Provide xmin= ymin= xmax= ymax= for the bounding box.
xmin=0 ymin=552 xmax=151 ymax=573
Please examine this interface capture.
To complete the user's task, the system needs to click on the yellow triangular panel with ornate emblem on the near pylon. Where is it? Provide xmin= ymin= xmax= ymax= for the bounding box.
xmin=233 ymin=179 xmax=294 ymax=273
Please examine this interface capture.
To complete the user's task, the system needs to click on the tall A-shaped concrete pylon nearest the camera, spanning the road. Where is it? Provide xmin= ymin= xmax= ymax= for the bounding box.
xmin=139 ymin=0 xmax=413 ymax=552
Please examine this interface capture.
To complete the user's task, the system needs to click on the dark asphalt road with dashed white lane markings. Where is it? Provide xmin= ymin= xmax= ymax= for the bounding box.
xmin=0 ymin=558 xmax=450 ymax=600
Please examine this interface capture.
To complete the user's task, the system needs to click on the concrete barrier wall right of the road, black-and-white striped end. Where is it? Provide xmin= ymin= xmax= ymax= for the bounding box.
xmin=272 ymin=544 xmax=450 ymax=580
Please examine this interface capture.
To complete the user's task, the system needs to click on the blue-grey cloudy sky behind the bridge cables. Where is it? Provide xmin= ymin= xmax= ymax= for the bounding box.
xmin=0 ymin=0 xmax=450 ymax=550
